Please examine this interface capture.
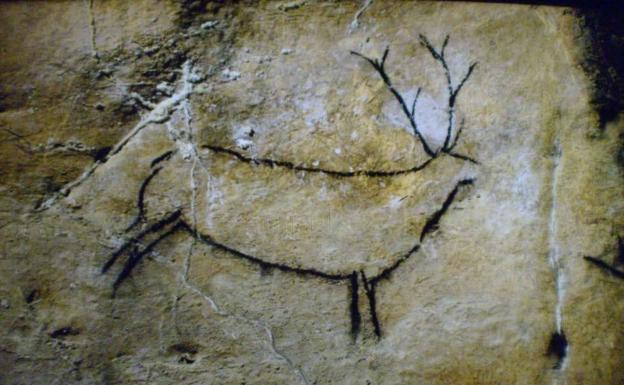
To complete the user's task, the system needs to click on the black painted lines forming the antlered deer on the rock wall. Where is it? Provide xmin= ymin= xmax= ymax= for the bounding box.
xmin=102 ymin=35 xmax=478 ymax=340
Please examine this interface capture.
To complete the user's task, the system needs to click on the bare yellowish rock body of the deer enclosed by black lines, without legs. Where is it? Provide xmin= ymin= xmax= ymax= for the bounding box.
xmin=150 ymin=153 xmax=466 ymax=276
